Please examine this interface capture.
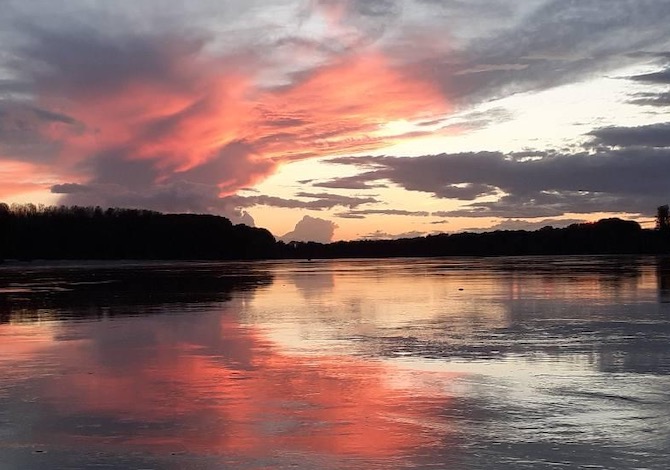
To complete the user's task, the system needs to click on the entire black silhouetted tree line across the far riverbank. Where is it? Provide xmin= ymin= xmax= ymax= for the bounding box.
xmin=0 ymin=203 xmax=670 ymax=260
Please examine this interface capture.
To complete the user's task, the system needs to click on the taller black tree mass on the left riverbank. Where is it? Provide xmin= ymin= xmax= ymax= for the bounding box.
xmin=0 ymin=203 xmax=276 ymax=260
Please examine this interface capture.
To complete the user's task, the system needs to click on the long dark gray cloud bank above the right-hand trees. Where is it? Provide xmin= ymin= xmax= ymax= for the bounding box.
xmin=330 ymin=120 xmax=670 ymax=218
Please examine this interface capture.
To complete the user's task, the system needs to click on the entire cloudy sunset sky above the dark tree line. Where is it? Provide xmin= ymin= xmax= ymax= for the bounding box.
xmin=0 ymin=0 xmax=670 ymax=242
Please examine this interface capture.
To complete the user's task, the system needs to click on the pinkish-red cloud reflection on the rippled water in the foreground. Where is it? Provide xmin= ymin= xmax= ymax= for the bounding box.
xmin=0 ymin=300 xmax=456 ymax=463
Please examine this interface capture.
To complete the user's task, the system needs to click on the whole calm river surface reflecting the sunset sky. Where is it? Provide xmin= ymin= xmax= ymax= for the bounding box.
xmin=0 ymin=257 xmax=670 ymax=470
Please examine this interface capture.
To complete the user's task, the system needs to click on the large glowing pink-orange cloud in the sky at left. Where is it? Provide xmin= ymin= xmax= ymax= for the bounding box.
xmin=0 ymin=25 xmax=447 ymax=210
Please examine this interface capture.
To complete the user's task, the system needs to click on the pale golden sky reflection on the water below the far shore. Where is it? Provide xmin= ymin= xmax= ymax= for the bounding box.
xmin=245 ymin=259 xmax=507 ymax=351
